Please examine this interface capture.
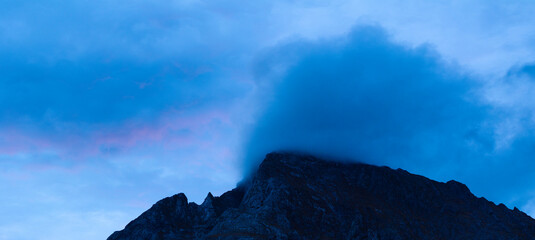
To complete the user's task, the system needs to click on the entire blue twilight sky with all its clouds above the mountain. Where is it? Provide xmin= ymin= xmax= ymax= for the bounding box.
xmin=0 ymin=0 xmax=535 ymax=240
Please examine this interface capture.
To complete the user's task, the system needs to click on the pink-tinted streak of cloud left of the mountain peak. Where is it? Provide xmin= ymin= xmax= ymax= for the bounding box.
xmin=0 ymin=106 xmax=237 ymax=172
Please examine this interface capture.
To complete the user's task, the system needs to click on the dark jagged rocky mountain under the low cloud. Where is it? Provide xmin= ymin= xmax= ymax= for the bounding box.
xmin=108 ymin=153 xmax=535 ymax=240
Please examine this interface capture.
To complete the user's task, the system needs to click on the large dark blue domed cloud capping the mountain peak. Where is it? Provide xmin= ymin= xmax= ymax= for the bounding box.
xmin=245 ymin=26 xmax=494 ymax=176
